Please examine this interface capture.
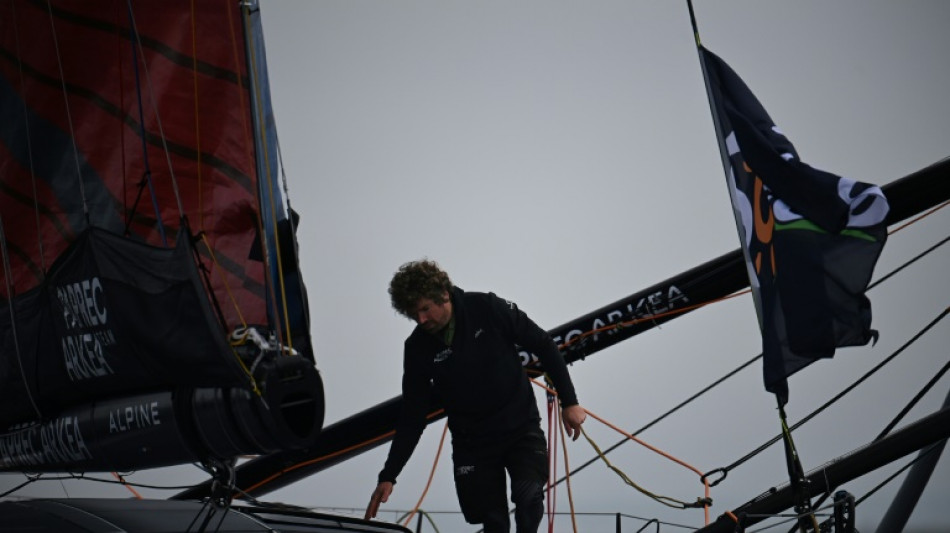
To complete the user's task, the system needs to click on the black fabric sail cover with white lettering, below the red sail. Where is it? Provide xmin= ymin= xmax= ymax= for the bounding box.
xmin=0 ymin=229 xmax=246 ymax=428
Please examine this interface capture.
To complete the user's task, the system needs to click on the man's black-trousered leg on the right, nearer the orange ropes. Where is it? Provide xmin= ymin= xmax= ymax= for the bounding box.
xmin=505 ymin=426 xmax=548 ymax=533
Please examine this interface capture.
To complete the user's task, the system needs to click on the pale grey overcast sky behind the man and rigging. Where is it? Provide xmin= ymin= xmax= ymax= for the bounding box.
xmin=0 ymin=0 xmax=950 ymax=531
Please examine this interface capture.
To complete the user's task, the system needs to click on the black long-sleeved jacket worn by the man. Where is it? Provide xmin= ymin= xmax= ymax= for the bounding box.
xmin=379 ymin=287 xmax=577 ymax=482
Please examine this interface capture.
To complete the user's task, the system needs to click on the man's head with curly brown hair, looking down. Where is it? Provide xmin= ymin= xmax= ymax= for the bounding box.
xmin=389 ymin=259 xmax=452 ymax=331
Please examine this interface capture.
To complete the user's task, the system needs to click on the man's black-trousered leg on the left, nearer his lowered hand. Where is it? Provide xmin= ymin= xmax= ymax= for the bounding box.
xmin=452 ymin=446 xmax=510 ymax=533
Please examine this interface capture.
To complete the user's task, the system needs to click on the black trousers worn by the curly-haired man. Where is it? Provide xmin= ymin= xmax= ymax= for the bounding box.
xmin=452 ymin=423 xmax=548 ymax=533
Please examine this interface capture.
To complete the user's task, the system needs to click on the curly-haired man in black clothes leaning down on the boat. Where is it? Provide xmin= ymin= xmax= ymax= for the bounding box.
xmin=366 ymin=260 xmax=587 ymax=533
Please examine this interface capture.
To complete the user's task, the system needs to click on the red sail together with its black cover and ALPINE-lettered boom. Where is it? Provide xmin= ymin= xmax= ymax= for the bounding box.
xmin=0 ymin=0 xmax=323 ymax=471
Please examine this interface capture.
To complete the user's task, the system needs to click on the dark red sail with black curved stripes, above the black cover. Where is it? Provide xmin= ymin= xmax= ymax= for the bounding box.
xmin=0 ymin=0 xmax=266 ymax=327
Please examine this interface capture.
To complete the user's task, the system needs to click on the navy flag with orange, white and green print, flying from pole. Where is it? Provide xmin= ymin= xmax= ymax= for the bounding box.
xmin=700 ymin=47 xmax=889 ymax=405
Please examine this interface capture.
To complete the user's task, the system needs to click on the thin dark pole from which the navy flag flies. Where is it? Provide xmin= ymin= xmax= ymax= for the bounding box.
xmin=686 ymin=0 xmax=818 ymax=533
